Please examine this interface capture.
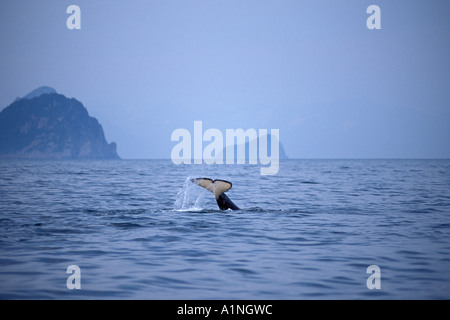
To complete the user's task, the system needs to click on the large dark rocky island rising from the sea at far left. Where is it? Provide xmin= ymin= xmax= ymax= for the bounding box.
xmin=0 ymin=87 xmax=119 ymax=159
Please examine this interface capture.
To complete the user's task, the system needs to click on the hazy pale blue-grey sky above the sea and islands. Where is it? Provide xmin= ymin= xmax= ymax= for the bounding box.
xmin=0 ymin=0 xmax=450 ymax=158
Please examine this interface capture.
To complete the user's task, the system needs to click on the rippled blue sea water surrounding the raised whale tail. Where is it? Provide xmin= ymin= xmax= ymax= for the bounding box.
xmin=0 ymin=160 xmax=450 ymax=299
